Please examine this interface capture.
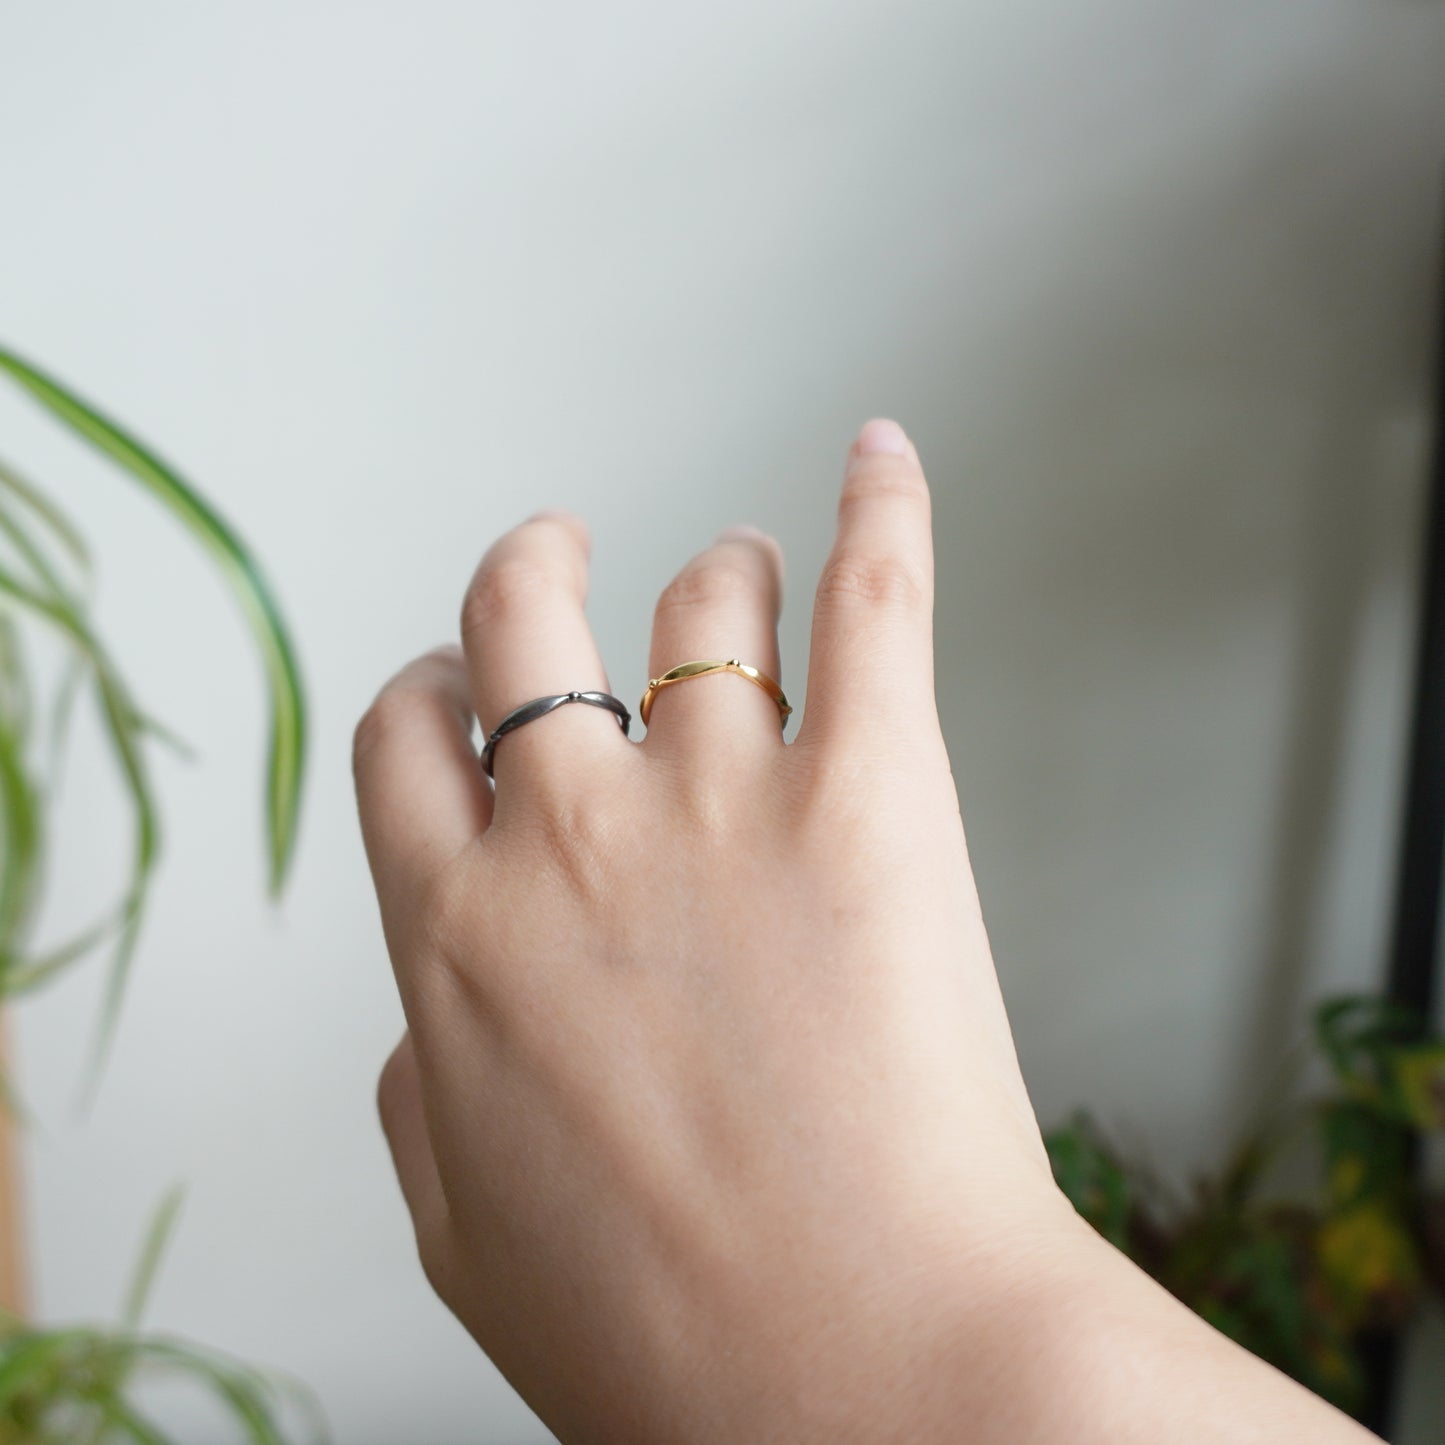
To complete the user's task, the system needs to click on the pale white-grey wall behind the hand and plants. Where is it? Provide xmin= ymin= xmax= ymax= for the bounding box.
xmin=0 ymin=0 xmax=1445 ymax=1445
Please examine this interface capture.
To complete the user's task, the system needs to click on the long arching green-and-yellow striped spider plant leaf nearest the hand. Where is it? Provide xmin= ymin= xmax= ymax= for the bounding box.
xmin=0 ymin=348 xmax=306 ymax=893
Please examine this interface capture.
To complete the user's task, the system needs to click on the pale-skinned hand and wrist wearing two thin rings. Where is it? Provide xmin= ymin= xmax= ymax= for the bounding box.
xmin=355 ymin=420 xmax=1374 ymax=1445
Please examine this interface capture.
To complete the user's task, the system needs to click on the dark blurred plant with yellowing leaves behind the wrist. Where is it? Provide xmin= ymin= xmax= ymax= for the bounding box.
xmin=1045 ymin=997 xmax=1445 ymax=1412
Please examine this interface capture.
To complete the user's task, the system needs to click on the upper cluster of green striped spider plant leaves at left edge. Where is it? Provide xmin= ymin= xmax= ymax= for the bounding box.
xmin=0 ymin=348 xmax=305 ymax=1058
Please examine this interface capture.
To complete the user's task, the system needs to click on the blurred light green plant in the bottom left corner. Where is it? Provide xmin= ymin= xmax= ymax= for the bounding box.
xmin=0 ymin=1191 xmax=328 ymax=1445
